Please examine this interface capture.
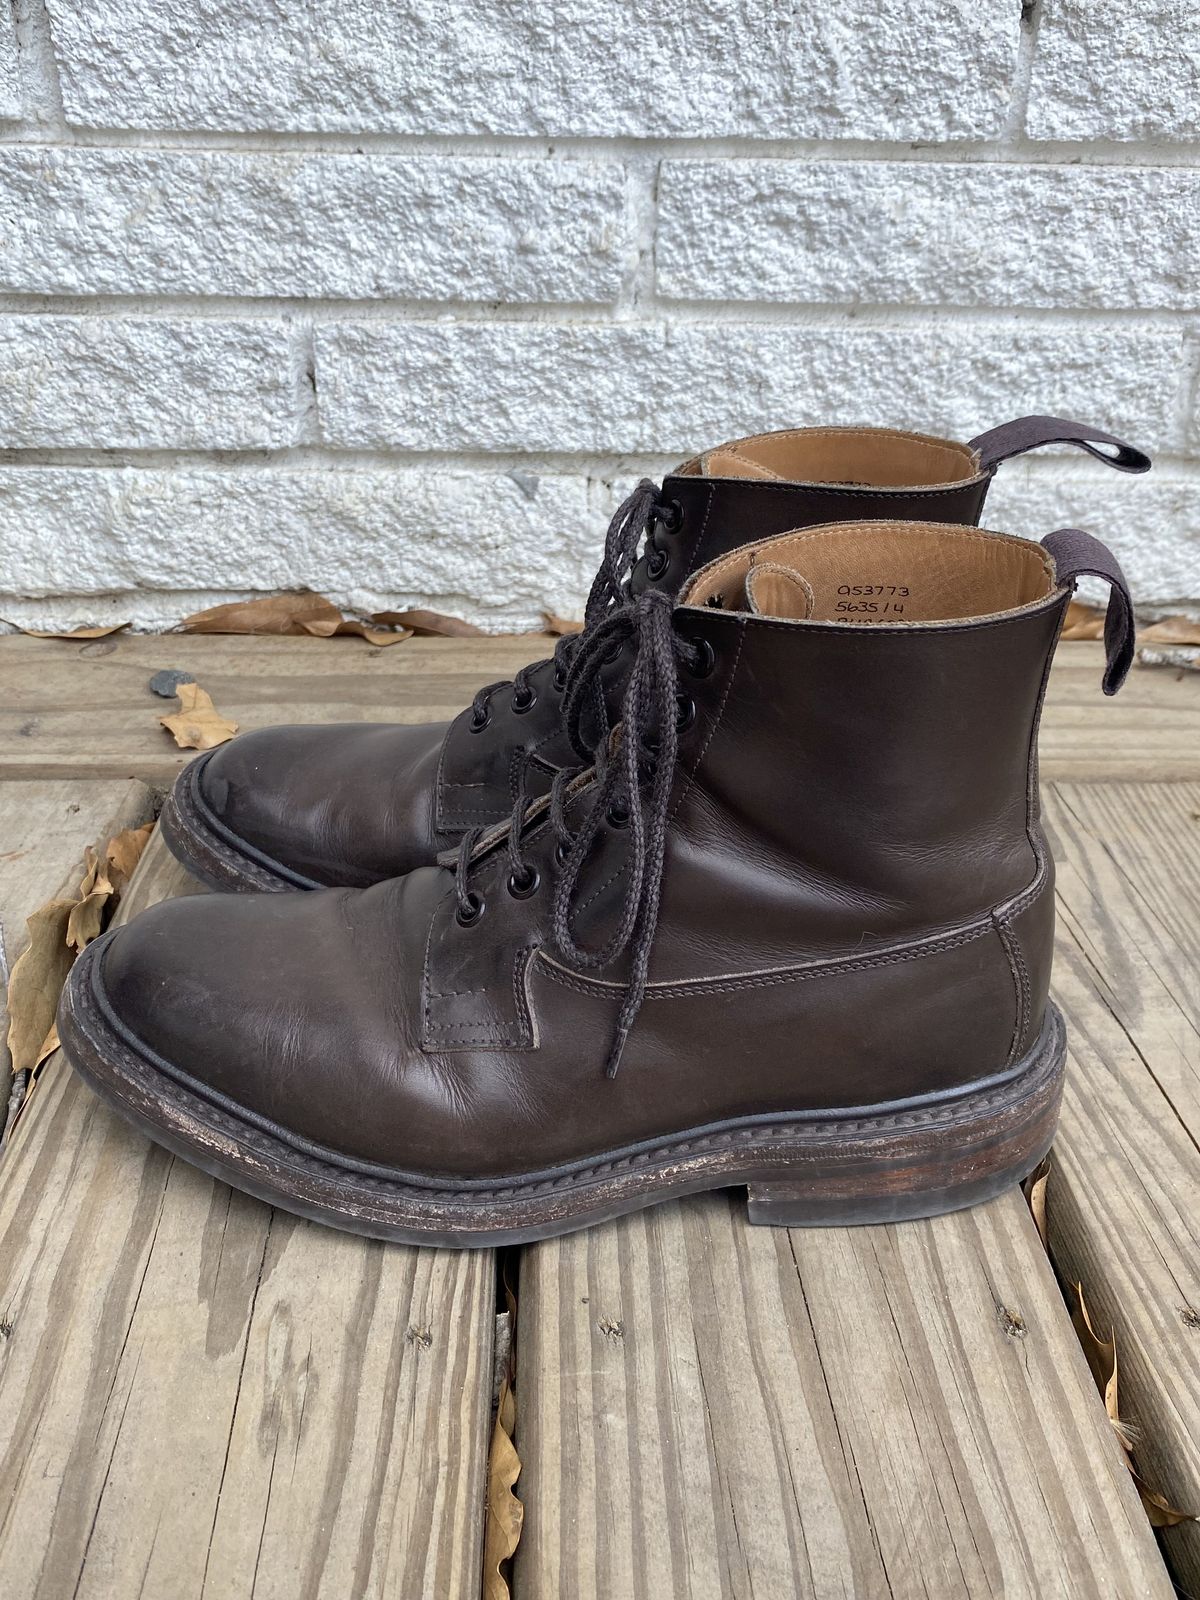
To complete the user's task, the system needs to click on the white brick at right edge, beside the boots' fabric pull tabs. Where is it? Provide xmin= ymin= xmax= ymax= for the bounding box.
xmin=984 ymin=462 xmax=1200 ymax=605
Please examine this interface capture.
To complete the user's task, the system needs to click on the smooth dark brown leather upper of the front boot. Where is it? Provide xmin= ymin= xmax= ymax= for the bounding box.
xmin=99 ymin=528 xmax=1069 ymax=1181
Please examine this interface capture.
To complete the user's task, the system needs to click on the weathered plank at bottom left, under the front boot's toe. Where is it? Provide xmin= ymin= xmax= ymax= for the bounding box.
xmin=0 ymin=840 xmax=494 ymax=1600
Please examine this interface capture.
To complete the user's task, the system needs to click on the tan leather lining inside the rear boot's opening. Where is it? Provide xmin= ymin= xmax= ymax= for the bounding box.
xmin=678 ymin=427 xmax=979 ymax=488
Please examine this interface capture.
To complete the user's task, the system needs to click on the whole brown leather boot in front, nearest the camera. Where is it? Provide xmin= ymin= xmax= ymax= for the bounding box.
xmin=59 ymin=523 xmax=1133 ymax=1245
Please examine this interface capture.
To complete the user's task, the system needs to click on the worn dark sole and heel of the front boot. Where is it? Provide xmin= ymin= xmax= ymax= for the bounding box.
xmin=58 ymin=939 xmax=1066 ymax=1248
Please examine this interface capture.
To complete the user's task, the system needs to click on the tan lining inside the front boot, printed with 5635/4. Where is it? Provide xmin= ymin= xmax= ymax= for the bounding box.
xmin=682 ymin=522 xmax=1058 ymax=626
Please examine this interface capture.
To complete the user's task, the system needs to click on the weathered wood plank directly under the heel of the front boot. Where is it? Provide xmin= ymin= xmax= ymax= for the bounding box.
xmin=515 ymin=1192 xmax=1171 ymax=1600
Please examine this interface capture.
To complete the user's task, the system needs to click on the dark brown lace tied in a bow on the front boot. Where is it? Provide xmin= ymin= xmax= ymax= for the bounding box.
xmin=454 ymin=589 xmax=712 ymax=1078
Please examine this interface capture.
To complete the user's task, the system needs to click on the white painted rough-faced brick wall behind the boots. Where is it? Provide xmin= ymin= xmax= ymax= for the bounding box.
xmin=0 ymin=0 xmax=1200 ymax=627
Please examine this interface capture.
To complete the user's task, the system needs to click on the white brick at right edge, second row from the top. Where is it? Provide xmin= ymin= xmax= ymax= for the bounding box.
xmin=656 ymin=160 xmax=1200 ymax=309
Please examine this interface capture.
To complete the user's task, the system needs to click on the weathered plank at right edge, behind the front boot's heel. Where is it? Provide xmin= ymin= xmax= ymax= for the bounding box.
xmin=1046 ymin=784 xmax=1200 ymax=1594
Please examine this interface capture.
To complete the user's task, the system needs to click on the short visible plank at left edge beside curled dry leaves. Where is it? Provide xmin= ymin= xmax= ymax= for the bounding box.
xmin=0 ymin=779 xmax=154 ymax=1088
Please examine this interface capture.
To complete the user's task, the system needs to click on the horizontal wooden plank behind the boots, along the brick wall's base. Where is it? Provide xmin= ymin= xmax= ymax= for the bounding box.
xmin=0 ymin=634 xmax=1200 ymax=784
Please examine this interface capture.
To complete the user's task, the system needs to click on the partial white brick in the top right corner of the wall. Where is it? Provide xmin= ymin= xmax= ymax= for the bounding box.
xmin=1027 ymin=0 xmax=1200 ymax=139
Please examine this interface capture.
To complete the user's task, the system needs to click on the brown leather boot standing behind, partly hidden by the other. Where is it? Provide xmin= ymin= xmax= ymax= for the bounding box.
xmin=163 ymin=416 xmax=1150 ymax=890
